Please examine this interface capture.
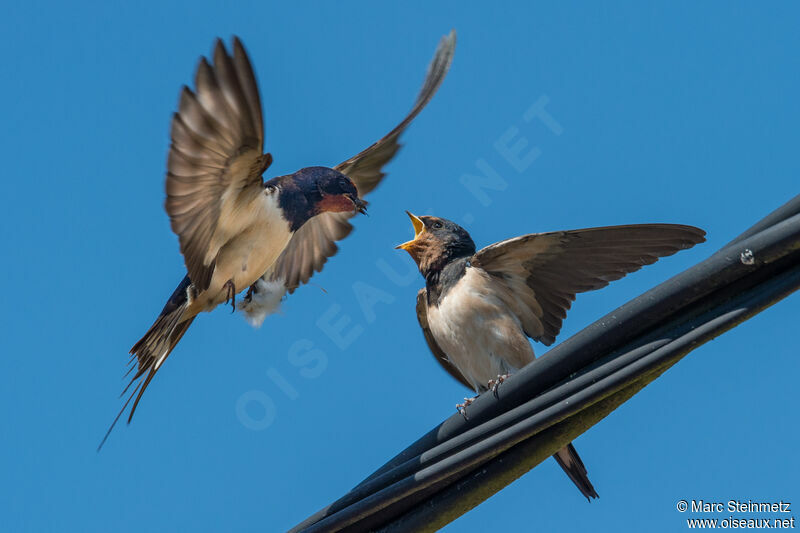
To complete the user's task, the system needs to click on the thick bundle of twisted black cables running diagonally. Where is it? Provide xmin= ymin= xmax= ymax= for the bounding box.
xmin=292 ymin=196 xmax=800 ymax=532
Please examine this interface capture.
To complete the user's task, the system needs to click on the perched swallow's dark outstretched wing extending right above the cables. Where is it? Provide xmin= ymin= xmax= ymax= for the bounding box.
xmin=472 ymin=224 xmax=705 ymax=346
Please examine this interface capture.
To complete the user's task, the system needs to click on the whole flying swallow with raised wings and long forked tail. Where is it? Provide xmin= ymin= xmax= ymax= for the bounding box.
xmin=100 ymin=32 xmax=455 ymax=447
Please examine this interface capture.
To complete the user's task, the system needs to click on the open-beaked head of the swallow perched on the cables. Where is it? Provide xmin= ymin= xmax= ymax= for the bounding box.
xmin=395 ymin=211 xmax=475 ymax=277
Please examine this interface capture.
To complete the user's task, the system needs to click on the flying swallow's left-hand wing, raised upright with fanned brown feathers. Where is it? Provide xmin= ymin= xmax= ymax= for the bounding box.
xmin=165 ymin=37 xmax=272 ymax=291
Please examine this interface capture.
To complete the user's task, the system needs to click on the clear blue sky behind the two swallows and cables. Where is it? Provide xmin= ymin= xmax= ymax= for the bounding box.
xmin=0 ymin=0 xmax=800 ymax=532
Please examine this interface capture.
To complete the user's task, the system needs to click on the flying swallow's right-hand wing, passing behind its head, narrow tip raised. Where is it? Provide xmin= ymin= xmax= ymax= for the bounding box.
xmin=265 ymin=32 xmax=456 ymax=292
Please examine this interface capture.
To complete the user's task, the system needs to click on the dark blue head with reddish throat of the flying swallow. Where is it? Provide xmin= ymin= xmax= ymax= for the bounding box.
xmin=296 ymin=167 xmax=367 ymax=215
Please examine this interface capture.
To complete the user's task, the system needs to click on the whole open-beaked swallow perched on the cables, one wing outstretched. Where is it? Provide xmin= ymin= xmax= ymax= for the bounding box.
xmin=397 ymin=212 xmax=705 ymax=499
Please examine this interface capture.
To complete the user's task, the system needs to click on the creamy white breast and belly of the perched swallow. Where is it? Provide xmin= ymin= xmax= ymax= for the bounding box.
xmin=428 ymin=268 xmax=534 ymax=392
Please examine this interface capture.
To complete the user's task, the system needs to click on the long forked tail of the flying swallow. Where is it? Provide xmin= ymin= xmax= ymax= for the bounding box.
xmin=97 ymin=276 xmax=194 ymax=451
